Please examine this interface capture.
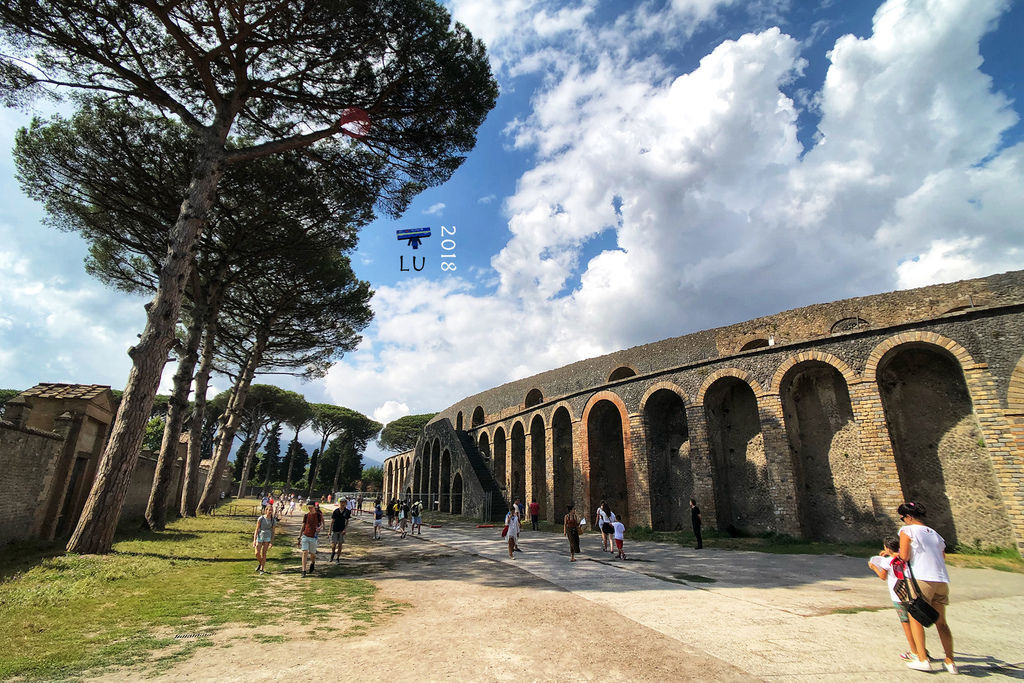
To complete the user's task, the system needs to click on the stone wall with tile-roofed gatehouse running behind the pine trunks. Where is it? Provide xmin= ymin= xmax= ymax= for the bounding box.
xmin=0 ymin=384 xmax=230 ymax=546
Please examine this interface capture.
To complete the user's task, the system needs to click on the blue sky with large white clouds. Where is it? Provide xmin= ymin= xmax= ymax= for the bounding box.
xmin=0 ymin=0 xmax=1024 ymax=464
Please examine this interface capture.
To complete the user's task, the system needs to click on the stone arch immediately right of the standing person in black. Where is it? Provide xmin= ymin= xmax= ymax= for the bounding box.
xmin=700 ymin=371 xmax=774 ymax=532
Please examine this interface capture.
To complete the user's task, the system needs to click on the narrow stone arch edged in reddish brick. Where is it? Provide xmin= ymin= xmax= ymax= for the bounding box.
xmin=583 ymin=391 xmax=634 ymax=526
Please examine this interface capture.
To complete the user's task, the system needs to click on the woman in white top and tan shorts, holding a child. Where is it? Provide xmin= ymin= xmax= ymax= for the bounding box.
xmin=896 ymin=503 xmax=957 ymax=674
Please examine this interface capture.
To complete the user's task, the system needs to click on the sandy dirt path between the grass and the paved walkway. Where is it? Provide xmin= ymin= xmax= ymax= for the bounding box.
xmin=108 ymin=522 xmax=750 ymax=681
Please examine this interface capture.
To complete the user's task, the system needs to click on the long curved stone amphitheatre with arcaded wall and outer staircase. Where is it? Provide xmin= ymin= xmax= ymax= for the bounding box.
xmin=384 ymin=271 xmax=1024 ymax=550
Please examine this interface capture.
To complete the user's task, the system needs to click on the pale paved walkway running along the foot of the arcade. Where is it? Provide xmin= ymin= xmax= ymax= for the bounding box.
xmin=382 ymin=517 xmax=1024 ymax=681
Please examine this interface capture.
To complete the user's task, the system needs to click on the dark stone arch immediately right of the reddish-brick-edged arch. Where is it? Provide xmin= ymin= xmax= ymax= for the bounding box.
xmin=640 ymin=382 xmax=694 ymax=530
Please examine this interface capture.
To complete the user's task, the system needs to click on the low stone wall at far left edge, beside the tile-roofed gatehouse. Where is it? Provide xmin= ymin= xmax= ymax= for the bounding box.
xmin=0 ymin=420 xmax=65 ymax=546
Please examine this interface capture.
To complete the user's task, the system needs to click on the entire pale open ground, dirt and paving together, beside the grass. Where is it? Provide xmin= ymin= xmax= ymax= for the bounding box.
xmin=96 ymin=509 xmax=1024 ymax=683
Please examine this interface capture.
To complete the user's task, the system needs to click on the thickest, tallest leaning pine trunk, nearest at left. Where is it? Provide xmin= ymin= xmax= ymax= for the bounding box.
xmin=68 ymin=136 xmax=227 ymax=553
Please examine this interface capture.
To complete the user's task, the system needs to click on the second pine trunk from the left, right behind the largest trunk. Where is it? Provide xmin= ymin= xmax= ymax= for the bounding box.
xmin=145 ymin=292 xmax=205 ymax=530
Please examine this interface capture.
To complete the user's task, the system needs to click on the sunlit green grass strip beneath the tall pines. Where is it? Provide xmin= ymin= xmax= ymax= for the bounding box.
xmin=0 ymin=509 xmax=394 ymax=679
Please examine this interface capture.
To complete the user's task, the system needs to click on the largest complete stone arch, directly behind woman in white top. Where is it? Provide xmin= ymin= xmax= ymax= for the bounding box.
xmin=865 ymin=333 xmax=1013 ymax=547
